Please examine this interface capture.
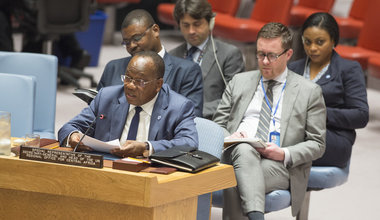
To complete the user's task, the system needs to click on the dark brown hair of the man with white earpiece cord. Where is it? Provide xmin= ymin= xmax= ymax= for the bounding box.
xmin=173 ymin=0 xmax=215 ymax=24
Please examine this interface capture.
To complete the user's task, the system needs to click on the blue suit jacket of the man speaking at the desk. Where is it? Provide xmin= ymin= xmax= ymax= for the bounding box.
xmin=58 ymin=84 xmax=198 ymax=152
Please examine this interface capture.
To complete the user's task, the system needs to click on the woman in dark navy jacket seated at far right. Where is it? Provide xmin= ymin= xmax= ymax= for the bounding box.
xmin=288 ymin=12 xmax=369 ymax=167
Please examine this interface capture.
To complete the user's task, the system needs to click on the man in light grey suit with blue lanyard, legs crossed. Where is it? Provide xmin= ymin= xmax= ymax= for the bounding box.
xmin=213 ymin=23 xmax=326 ymax=220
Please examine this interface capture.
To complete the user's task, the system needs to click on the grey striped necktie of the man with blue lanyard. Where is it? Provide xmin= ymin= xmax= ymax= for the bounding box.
xmin=256 ymin=80 xmax=276 ymax=141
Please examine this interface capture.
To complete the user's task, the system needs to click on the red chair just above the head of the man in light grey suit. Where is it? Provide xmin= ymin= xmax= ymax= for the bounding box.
xmin=213 ymin=0 xmax=293 ymax=43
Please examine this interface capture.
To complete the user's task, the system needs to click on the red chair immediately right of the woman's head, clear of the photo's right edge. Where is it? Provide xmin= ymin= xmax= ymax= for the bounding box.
xmin=335 ymin=0 xmax=368 ymax=39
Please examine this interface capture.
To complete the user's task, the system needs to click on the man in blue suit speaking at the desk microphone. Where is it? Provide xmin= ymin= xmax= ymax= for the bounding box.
xmin=58 ymin=51 xmax=198 ymax=157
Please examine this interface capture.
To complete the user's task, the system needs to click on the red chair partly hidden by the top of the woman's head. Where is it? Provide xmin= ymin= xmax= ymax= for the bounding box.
xmin=290 ymin=0 xmax=335 ymax=27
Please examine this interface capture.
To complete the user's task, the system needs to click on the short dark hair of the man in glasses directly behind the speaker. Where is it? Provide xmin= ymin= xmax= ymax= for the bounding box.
xmin=121 ymin=9 xmax=156 ymax=29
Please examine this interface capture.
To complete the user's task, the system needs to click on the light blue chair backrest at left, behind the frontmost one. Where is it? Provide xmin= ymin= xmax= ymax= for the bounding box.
xmin=0 ymin=52 xmax=58 ymax=139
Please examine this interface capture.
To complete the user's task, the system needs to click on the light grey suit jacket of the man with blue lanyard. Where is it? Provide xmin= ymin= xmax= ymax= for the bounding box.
xmin=213 ymin=71 xmax=326 ymax=216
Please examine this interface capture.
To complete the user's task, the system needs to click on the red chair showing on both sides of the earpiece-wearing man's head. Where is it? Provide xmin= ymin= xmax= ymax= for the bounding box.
xmin=157 ymin=0 xmax=240 ymax=26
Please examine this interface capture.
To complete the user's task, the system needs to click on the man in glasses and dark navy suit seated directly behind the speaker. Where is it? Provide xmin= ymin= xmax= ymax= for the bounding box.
xmin=97 ymin=9 xmax=203 ymax=117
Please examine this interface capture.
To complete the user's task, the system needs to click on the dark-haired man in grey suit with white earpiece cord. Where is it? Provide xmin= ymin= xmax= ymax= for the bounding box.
xmin=169 ymin=0 xmax=245 ymax=119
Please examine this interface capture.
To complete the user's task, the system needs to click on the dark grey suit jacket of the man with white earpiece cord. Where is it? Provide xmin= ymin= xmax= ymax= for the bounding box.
xmin=169 ymin=39 xmax=245 ymax=119
